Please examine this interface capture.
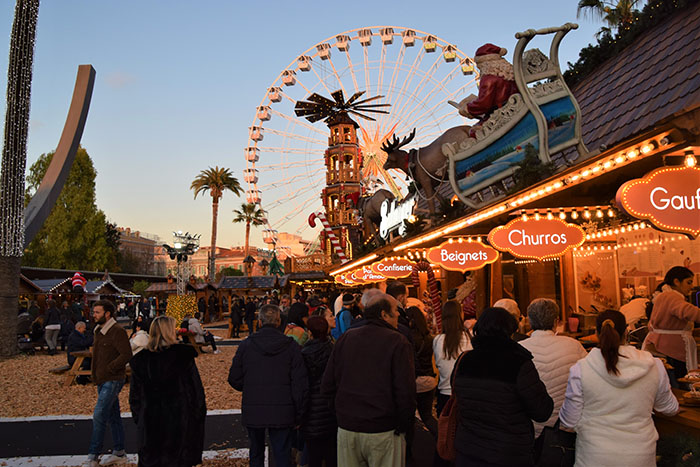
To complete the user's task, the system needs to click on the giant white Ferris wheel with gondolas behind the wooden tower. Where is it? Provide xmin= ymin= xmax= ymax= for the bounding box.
xmin=243 ymin=26 xmax=478 ymax=243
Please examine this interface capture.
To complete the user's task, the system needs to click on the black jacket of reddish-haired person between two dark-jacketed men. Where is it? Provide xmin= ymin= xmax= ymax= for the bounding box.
xmin=301 ymin=339 xmax=338 ymax=439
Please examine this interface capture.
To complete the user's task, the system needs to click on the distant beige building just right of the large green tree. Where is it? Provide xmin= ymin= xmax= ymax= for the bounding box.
xmin=118 ymin=227 xmax=165 ymax=275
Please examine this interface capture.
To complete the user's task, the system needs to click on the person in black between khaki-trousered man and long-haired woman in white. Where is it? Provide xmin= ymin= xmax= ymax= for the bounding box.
xmin=406 ymin=306 xmax=437 ymax=439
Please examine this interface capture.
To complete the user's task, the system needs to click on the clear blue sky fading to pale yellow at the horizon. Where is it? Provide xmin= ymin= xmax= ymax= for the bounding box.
xmin=0 ymin=0 xmax=600 ymax=247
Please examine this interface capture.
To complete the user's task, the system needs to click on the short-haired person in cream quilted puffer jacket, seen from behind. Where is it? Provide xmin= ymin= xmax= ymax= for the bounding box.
xmin=519 ymin=298 xmax=588 ymax=438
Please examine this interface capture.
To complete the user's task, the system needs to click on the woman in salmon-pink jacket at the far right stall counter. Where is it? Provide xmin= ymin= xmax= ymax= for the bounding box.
xmin=642 ymin=266 xmax=700 ymax=383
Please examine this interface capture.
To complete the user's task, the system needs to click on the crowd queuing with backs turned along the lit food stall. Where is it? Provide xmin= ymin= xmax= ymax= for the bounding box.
xmin=229 ymin=267 xmax=700 ymax=467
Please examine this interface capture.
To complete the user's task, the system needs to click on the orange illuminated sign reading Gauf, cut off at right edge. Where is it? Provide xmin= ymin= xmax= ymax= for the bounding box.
xmin=616 ymin=167 xmax=700 ymax=238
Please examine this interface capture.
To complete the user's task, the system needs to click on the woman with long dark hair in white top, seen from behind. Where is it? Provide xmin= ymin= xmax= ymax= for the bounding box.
xmin=433 ymin=300 xmax=472 ymax=417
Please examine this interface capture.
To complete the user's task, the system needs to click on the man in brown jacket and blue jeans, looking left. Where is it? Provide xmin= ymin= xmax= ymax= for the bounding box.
xmin=88 ymin=300 xmax=131 ymax=467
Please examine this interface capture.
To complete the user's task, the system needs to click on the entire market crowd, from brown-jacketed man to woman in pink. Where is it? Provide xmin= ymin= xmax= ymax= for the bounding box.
xmin=19 ymin=267 xmax=700 ymax=467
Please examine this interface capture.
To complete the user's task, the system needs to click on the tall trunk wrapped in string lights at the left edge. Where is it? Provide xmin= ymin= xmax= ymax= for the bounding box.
xmin=0 ymin=0 xmax=39 ymax=356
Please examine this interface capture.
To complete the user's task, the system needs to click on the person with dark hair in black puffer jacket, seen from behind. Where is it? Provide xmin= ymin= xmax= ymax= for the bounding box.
xmin=452 ymin=307 xmax=554 ymax=467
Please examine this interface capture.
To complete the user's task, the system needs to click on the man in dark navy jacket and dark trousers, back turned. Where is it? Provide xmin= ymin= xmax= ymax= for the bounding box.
xmin=228 ymin=305 xmax=309 ymax=467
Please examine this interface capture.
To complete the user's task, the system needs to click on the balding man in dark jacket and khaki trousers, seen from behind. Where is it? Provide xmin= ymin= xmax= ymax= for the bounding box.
xmin=321 ymin=293 xmax=416 ymax=465
